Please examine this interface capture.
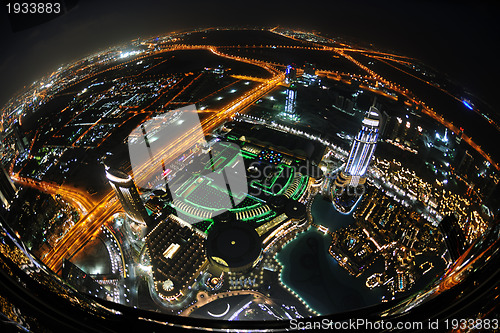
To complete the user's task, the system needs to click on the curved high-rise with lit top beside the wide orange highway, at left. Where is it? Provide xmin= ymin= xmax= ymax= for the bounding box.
xmin=106 ymin=166 xmax=151 ymax=227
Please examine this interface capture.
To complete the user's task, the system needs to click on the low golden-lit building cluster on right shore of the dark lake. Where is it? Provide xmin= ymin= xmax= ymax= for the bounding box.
xmin=329 ymin=188 xmax=443 ymax=297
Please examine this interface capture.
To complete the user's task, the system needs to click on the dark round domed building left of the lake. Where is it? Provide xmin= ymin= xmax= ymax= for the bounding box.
xmin=205 ymin=221 xmax=262 ymax=272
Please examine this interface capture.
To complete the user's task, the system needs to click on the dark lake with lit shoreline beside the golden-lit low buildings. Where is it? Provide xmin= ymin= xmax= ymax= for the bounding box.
xmin=277 ymin=196 xmax=383 ymax=314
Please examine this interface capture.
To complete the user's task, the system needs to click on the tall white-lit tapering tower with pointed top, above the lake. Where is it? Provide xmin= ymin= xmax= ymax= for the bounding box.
xmin=335 ymin=106 xmax=380 ymax=187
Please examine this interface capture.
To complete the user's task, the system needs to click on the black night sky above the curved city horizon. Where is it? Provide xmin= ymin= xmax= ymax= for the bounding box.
xmin=0 ymin=0 xmax=500 ymax=112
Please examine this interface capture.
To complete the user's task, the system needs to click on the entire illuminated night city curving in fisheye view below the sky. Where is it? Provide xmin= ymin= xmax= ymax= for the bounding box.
xmin=0 ymin=22 xmax=500 ymax=330
